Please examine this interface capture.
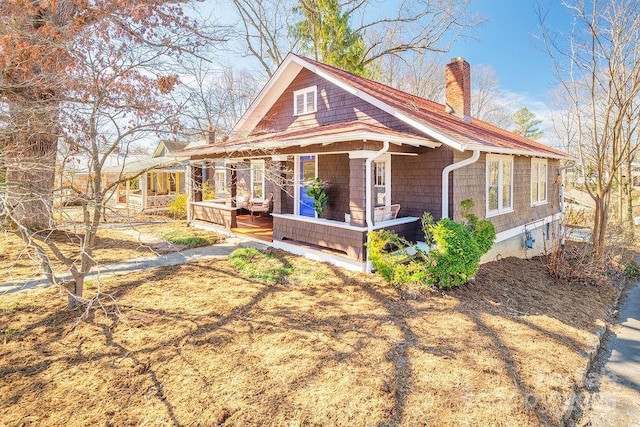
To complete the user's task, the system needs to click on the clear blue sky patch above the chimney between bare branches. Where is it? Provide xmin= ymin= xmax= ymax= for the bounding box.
xmin=449 ymin=0 xmax=571 ymax=103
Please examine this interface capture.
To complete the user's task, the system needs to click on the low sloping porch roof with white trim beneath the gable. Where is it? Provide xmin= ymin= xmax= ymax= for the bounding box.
xmin=182 ymin=122 xmax=442 ymax=158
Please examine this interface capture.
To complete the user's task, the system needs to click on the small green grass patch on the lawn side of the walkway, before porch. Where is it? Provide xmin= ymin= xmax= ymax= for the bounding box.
xmin=229 ymin=248 xmax=293 ymax=284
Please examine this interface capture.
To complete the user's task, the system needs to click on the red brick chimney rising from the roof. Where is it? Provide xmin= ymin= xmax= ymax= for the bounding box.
xmin=445 ymin=56 xmax=471 ymax=123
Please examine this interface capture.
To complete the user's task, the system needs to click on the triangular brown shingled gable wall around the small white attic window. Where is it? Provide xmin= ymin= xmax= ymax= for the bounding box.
xmin=250 ymin=68 xmax=424 ymax=140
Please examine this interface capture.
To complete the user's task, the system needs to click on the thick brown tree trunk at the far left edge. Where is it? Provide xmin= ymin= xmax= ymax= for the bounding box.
xmin=4 ymin=102 xmax=58 ymax=231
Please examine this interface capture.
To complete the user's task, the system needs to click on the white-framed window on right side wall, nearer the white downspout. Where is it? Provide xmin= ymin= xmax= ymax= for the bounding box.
xmin=487 ymin=155 xmax=513 ymax=217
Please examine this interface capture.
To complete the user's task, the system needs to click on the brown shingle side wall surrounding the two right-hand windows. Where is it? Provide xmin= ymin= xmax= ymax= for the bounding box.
xmin=452 ymin=153 xmax=560 ymax=232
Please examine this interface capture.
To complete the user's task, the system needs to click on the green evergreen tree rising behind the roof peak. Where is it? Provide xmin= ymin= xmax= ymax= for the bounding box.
xmin=292 ymin=0 xmax=366 ymax=75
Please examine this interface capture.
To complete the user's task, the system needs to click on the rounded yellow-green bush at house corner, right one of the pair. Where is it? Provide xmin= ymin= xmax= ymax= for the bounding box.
xmin=427 ymin=218 xmax=482 ymax=288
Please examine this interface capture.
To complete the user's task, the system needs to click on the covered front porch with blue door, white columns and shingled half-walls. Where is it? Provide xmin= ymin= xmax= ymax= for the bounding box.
xmin=188 ymin=129 xmax=447 ymax=269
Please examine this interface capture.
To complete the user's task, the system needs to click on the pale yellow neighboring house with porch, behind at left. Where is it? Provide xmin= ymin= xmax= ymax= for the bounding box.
xmin=103 ymin=141 xmax=188 ymax=212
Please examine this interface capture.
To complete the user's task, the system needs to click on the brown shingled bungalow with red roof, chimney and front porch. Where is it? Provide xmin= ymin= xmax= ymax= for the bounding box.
xmin=182 ymin=54 xmax=570 ymax=269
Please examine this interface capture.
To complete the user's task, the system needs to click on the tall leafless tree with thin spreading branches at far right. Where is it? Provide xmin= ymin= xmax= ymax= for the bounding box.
xmin=539 ymin=0 xmax=640 ymax=259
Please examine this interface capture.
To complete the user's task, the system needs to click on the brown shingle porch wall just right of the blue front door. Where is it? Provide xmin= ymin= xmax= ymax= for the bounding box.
xmin=318 ymin=154 xmax=350 ymax=221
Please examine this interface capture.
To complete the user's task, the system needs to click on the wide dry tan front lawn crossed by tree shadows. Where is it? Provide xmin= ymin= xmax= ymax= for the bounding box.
xmin=0 ymin=251 xmax=616 ymax=426
